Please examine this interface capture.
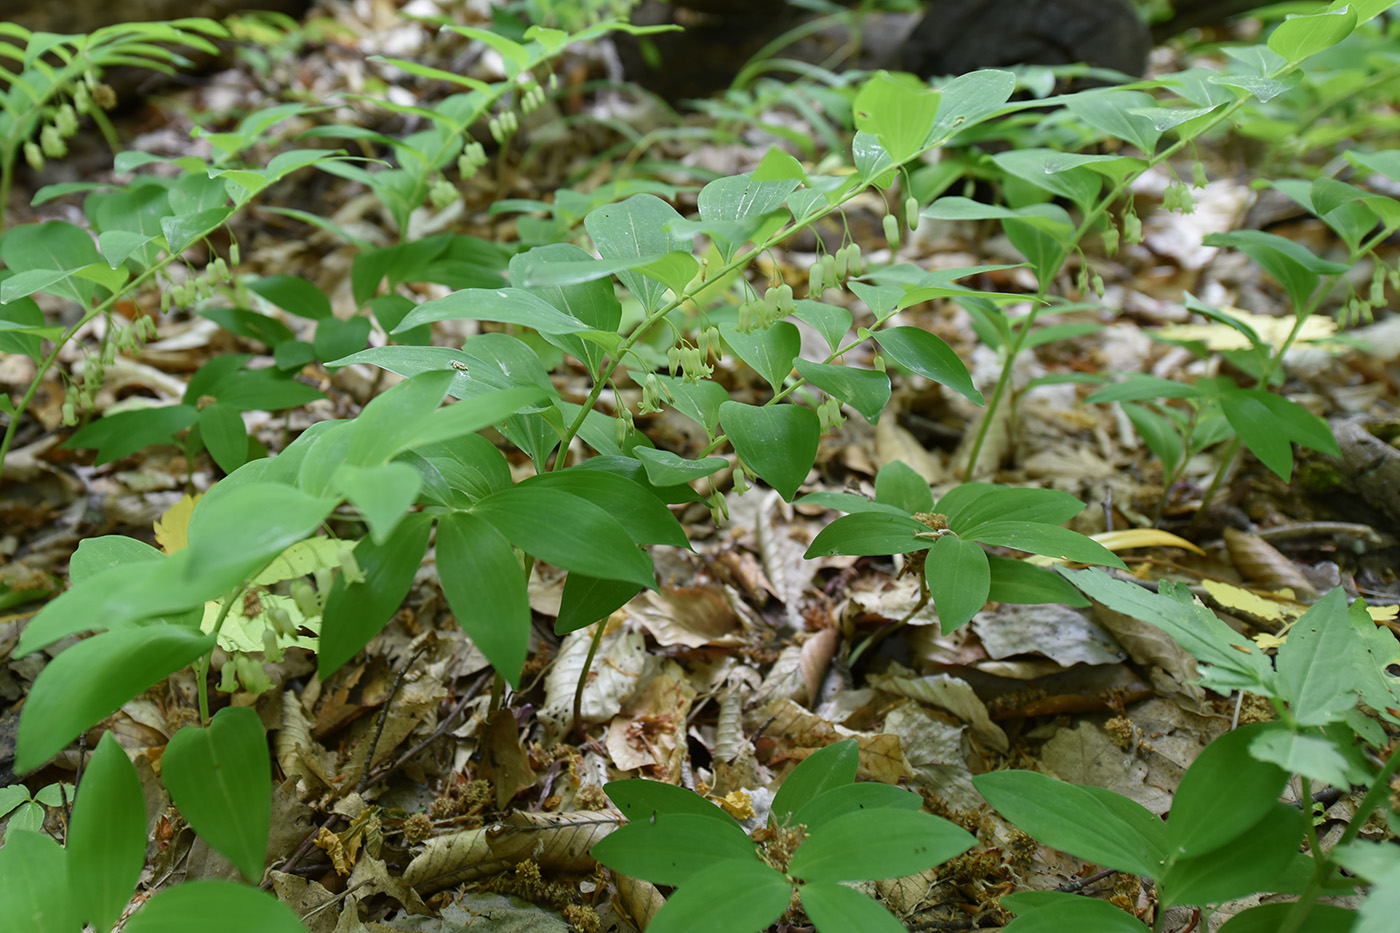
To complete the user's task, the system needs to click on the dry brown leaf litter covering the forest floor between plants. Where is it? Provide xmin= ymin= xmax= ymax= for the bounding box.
xmin=0 ymin=1 xmax=1400 ymax=933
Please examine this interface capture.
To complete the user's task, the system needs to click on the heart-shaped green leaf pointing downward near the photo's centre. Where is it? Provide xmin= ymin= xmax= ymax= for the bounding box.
xmin=720 ymin=401 xmax=822 ymax=502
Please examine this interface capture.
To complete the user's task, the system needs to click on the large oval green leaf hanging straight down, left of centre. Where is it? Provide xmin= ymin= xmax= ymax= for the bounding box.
xmin=437 ymin=509 xmax=529 ymax=689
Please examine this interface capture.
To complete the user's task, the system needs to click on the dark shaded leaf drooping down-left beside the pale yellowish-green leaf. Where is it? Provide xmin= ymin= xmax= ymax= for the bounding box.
xmin=316 ymin=513 xmax=433 ymax=679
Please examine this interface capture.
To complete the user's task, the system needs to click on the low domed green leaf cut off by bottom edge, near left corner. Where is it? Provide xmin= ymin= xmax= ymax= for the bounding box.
xmin=123 ymin=879 xmax=307 ymax=933
